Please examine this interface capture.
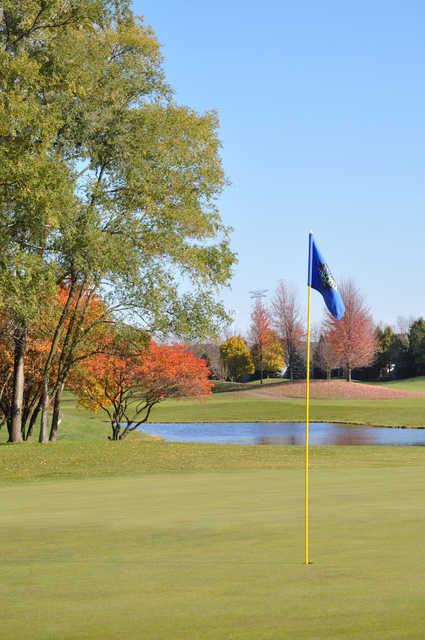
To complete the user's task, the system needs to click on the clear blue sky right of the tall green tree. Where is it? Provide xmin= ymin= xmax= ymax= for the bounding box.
xmin=134 ymin=0 xmax=425 ymax=330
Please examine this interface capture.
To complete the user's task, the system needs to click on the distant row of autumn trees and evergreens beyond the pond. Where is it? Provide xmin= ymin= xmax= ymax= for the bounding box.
xmin=192 ymin=281 xmax=425 ymax=381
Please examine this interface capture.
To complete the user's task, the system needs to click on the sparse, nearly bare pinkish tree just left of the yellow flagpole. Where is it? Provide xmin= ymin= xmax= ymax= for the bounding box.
xmin=272 ymin=280 xmax=304 ymax=382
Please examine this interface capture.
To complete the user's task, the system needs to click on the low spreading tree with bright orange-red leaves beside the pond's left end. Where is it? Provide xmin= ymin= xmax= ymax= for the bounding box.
xmin=73 ymin=341 xmax=212 ymax=440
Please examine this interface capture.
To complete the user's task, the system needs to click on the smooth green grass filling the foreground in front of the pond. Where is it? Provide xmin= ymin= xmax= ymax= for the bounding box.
xmin=0 ymin=442 xmax=425 ymax=640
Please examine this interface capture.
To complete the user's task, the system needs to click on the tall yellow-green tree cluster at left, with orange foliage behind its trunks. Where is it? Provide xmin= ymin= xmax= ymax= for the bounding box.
xmin=0 ymin=0 xmax=234 ymax=442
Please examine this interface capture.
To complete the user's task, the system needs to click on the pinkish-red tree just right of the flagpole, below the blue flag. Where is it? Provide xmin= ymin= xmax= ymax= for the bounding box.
xmin=325 ymin=280 xmax=376 ymax=382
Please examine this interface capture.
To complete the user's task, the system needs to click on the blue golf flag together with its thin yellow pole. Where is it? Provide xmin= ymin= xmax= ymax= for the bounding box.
xmin=304 ymin=233 xmax=345 ymax=564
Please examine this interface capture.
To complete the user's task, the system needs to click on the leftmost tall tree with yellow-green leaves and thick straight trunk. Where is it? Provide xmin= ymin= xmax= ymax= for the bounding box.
xmin=0 ymin=0 xmax=112 ymax=442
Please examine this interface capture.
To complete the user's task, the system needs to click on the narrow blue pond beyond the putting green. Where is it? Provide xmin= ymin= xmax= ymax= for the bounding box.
xmin=142 ymin=422 xmax=425 ymax=446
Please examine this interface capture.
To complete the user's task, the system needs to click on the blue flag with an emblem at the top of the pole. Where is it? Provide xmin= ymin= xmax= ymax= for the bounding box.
xmin=308 ymin=233 xmax=345 ymax=320
